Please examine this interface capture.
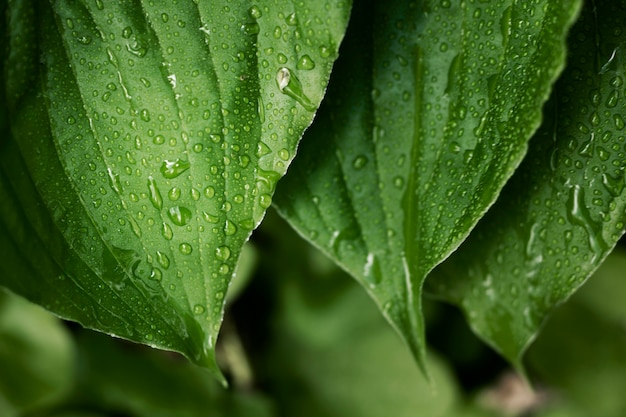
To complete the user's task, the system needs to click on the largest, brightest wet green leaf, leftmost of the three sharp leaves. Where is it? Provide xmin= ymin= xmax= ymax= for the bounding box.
xmin=0 ymin=0 xmax=350 ymax=378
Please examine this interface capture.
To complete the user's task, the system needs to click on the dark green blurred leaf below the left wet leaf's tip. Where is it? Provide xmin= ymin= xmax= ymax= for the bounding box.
xmin=64 ymin=332 xmax=274 ymax=417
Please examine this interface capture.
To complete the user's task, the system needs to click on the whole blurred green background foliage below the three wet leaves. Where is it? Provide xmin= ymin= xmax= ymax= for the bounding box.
xmin=0 ymin=212 xmax=626 ymax=417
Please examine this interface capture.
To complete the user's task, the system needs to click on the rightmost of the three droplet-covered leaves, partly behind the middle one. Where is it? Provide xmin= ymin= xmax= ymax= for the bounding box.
xmin=429 ymin=2 xmax=626 ymax=366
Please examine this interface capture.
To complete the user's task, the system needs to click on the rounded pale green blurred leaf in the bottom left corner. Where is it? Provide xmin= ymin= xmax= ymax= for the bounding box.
xmin=0 ymin=289 xmax=74 ymax=417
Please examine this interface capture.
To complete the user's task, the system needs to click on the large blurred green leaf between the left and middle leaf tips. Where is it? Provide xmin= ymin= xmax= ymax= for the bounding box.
xmin=254 ymin=213 xmax=458 ymax=417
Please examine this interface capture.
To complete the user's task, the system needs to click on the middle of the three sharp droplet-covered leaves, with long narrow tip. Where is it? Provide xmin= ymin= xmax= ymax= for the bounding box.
xmin=275 ymin=1 xmax=579 ymax=370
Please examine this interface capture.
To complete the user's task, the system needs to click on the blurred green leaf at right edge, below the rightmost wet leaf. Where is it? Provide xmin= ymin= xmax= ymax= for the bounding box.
xmin=527 ymin=250 xmax=626 ymax=417
